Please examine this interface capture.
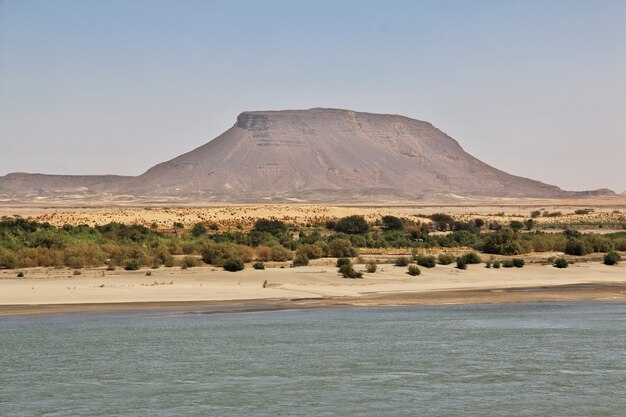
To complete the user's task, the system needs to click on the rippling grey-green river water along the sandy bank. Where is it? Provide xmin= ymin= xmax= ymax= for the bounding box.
xmin=0 ymin=303 xmax=626 ymax=417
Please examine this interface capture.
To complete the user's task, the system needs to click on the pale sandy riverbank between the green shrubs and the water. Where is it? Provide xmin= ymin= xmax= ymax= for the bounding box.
xmin=0 ymin=261 xmax=626 ymax=315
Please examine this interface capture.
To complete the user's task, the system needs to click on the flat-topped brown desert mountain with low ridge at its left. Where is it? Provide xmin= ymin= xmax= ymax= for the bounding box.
xmin=0 ymin=108 xmax=615 ymax=202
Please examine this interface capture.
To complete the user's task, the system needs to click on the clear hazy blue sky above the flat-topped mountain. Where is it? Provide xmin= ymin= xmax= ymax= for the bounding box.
xmin=0 ymin=0 xmax=626 ymax=192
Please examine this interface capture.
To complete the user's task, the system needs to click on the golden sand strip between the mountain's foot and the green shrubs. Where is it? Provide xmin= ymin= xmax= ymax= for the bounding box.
xmin=0 ymin=198 xmax=626 ymax=232
